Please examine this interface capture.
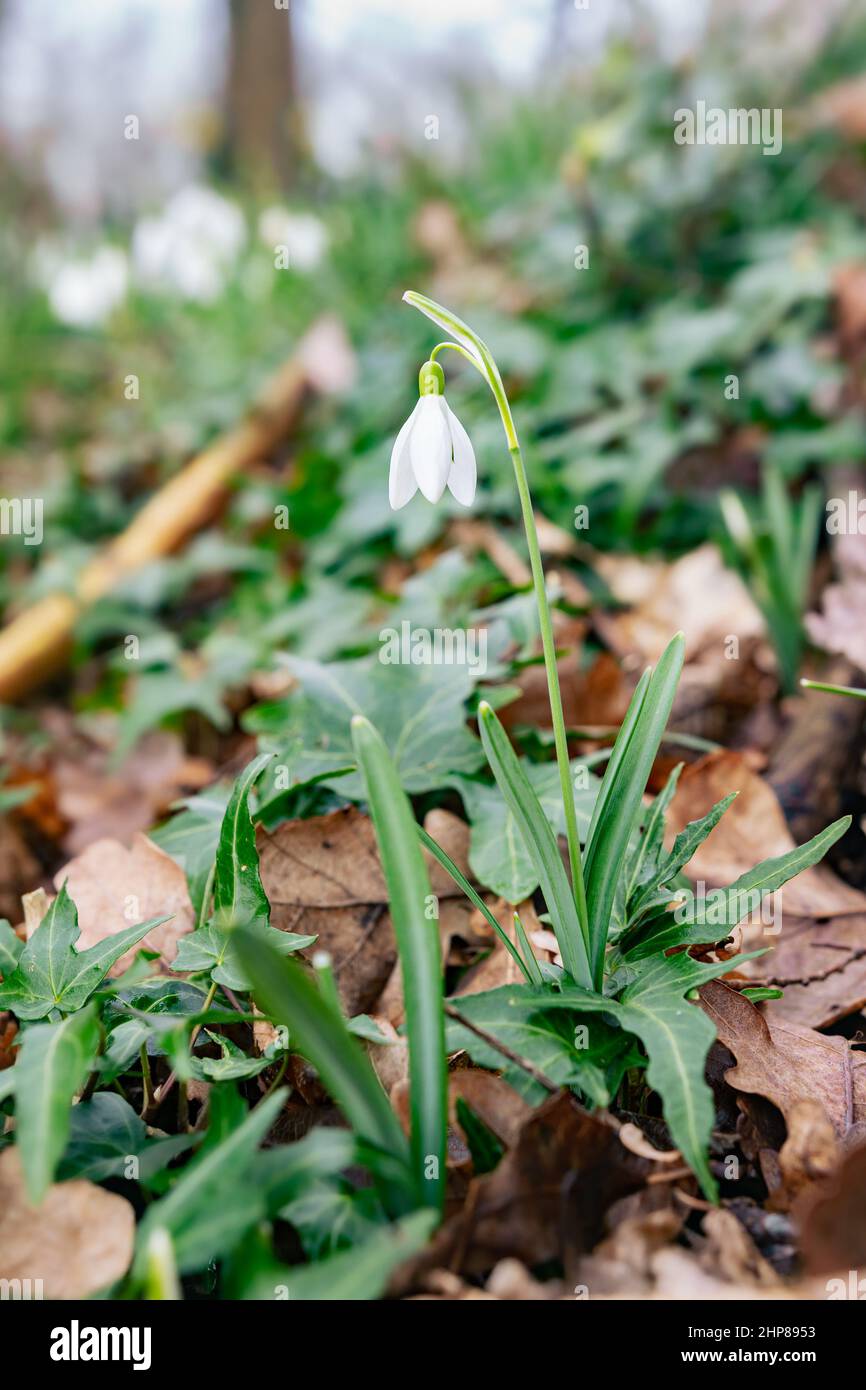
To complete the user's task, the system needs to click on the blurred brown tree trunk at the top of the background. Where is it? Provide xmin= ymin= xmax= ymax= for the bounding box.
xmin=220 ymin=0 xmax=304 ymax=193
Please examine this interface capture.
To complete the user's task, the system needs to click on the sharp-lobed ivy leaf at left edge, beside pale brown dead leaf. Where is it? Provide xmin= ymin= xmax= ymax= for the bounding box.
xmin=0 ymin=883 xmax=168 ymax=1019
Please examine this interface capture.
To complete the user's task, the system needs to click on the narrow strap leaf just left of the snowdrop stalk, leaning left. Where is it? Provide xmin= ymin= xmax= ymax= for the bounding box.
xmin=478 ymin=703 xmax=592 ymax=988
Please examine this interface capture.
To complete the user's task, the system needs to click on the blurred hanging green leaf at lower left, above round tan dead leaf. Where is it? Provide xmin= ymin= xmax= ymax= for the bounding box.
xmin=15 ymin=1009 xmax=99 ymax=1207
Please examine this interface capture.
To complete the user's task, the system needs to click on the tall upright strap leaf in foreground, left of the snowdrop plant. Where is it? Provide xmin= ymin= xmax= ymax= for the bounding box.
xmin=352 ymin=716 xmax=448 ymax=1208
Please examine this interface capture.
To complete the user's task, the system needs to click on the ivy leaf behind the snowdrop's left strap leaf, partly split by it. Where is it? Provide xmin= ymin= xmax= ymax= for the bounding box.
xmin=448 ymin=758 xmax=601 ymax=904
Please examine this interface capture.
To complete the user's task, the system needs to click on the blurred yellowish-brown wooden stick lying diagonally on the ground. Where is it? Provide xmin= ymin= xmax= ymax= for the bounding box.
xmin=0 ymin=321 xmax=341 ymax=701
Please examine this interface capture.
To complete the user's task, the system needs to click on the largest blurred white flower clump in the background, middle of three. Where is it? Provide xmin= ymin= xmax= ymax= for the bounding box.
xmin=132 ymin=183 xmax=246 ymax=303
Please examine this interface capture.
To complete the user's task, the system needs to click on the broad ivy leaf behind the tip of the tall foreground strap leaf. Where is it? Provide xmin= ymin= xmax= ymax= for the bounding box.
xmin=246 ymin=656 xmax=484 ymax=815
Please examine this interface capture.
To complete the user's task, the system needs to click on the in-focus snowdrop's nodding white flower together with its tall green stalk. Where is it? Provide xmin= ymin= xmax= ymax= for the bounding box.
xmin=389 ymin=291 xmax=594 ymax=959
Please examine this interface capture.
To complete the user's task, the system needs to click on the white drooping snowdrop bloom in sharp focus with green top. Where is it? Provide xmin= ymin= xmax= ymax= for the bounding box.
xmin=388 ymin=361 xmax=475 ymax=512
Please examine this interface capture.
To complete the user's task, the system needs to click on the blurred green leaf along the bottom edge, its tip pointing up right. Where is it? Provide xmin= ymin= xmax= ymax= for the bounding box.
xmin=231 ymin=1211 xmax=436 ymax=1302
